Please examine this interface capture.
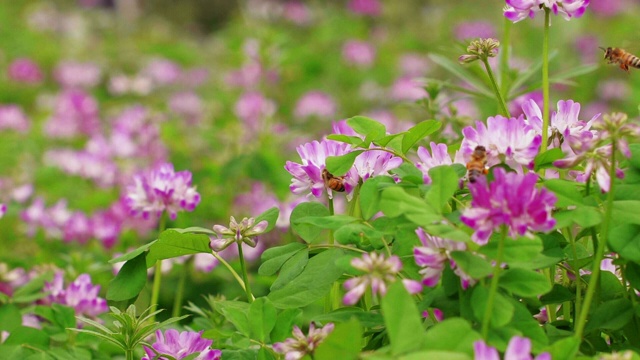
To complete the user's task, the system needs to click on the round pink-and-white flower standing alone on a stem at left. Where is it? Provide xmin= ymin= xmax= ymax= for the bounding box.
xmin=126 ymin=163 xmax=200 ymax=220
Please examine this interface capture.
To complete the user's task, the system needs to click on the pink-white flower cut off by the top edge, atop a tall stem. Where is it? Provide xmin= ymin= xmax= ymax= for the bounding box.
xmin=504 ymin=0 xmax=590 ymax=22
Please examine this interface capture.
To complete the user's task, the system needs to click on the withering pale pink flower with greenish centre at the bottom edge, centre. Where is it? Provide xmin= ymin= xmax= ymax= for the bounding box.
xmin=273 ymin=323 xmax=334 ymax=360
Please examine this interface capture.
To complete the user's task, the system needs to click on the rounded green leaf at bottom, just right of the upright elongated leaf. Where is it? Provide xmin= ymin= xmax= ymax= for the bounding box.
xmin=426 ymin=318 xmax=482 ymax=354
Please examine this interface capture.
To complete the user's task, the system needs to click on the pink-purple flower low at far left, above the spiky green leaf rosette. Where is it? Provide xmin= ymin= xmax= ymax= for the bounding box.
xmin=43 ymin=272 xmax=109 ymax=317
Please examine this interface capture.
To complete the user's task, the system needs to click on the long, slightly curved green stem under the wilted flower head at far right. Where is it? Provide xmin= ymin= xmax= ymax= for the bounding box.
xmin=575 ymin=143 xmax=617 ymax=340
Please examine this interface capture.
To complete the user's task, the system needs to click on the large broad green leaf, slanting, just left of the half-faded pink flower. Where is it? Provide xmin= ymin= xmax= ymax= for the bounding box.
xmin=268 ymin=249 xmax=344 ymax=309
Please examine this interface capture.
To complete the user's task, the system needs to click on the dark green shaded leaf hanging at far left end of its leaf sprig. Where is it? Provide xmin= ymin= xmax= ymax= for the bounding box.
xmin=107 ymin=252 xmax=147 ymax=301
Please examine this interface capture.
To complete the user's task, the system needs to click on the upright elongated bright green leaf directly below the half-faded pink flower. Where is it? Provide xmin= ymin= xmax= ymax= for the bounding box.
xmin=382 ymin=281 xmax=426 ymax=355
